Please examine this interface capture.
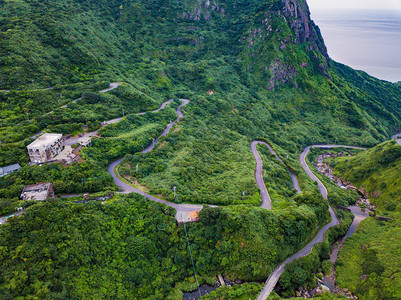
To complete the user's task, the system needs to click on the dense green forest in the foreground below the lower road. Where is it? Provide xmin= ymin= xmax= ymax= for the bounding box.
xmin=0 ymin=195 xmax=332 ymax=299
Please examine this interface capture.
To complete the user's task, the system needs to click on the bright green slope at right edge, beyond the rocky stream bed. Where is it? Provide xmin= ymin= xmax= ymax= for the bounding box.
xmin=332 ymin=140 xmax=401 ymax=299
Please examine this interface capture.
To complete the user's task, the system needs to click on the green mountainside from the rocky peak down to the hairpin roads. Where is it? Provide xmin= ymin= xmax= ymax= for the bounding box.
xmin=0 ymin=0 xmax=401 ymax=204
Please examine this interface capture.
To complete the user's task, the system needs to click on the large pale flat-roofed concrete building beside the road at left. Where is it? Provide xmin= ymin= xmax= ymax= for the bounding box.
xmin=27 ymin=133 xmax=63 ymax=164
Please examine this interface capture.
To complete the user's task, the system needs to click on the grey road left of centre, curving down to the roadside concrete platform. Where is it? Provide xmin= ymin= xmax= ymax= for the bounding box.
xmin=107 ymin=99 xmax=203 ymax=222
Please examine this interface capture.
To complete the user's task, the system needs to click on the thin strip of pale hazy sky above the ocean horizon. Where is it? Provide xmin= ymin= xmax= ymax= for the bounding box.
xmin=307 ymin=0 xmax=401 ymax=11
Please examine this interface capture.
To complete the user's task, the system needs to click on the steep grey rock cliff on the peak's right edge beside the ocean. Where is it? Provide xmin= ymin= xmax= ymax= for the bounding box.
xmin=283 ymin=0 xmax=329 ymax=63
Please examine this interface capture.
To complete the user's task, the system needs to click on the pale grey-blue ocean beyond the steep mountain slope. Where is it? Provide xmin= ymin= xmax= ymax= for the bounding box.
xmin=311 ymin=8 xmax=401 ymax=82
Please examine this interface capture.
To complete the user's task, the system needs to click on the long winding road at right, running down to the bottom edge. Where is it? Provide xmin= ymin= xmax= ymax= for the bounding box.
xmin=257 ymin=145 xmax=366 ymax=300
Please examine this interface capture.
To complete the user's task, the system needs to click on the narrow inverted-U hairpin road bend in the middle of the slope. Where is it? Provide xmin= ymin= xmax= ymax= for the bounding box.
xmin=251 ymin=141 xmax=301 ymax=210
